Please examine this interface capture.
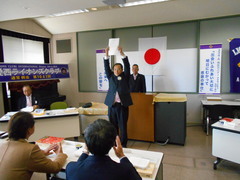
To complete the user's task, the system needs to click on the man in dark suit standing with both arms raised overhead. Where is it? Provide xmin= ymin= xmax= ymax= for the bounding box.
xmin=104 ymin=47 xmax=133 ymax=147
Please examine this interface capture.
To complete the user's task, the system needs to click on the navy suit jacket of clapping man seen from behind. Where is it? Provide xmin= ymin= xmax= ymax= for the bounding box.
xmin=66 ymin=153 xmax=142 ymax=180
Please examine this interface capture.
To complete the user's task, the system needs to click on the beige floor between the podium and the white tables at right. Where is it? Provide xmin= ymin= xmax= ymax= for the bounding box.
xmin=71 ymin=126 xmax=240 ymax=180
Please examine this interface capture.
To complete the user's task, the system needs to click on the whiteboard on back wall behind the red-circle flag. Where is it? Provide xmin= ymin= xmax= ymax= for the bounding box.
xmin=114 ymin=48 xmax=198 ymax=92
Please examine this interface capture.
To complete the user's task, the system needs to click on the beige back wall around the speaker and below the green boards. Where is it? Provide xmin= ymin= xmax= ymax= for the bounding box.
xmin=51 ymin=33 xmax=239 ymax=124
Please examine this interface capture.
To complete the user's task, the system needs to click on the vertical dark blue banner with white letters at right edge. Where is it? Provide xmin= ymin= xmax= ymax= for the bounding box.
xmin=229 ymin=38 xmax=240 ymax=93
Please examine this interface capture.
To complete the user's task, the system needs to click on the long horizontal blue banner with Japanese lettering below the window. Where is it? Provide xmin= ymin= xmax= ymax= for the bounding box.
xmin=0 ymin=63 xmax=70 ymax=82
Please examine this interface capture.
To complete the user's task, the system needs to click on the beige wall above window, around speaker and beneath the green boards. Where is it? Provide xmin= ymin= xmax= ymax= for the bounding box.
xmin=0 ymin=20 xmax=239 ymax=124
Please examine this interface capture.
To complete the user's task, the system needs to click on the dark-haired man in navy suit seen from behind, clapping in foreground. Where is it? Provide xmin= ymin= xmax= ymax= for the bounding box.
xmin=66 ymin=119 xmax=142 ymax=180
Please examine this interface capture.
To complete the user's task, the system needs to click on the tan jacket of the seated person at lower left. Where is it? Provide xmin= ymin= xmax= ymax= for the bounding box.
xmin=0 ymin=139 xmax=67 ymax=180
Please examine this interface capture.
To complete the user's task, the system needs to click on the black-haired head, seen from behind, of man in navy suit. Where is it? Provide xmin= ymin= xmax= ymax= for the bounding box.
xmin=84 ymin=119 xmax=117 ymax=156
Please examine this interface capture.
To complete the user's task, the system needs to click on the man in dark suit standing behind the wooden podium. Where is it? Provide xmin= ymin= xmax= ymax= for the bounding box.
xmin=129 ymin=64 xmax=146 ymax=93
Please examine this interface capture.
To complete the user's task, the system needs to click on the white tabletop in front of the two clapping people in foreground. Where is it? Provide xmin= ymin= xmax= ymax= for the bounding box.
xmin=39 ymin=140 xmax=163 ymax=180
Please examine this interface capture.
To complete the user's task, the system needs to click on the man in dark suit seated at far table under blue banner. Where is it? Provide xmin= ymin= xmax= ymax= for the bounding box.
xmin=18 ymin=85 xmax=39 ymax=110
